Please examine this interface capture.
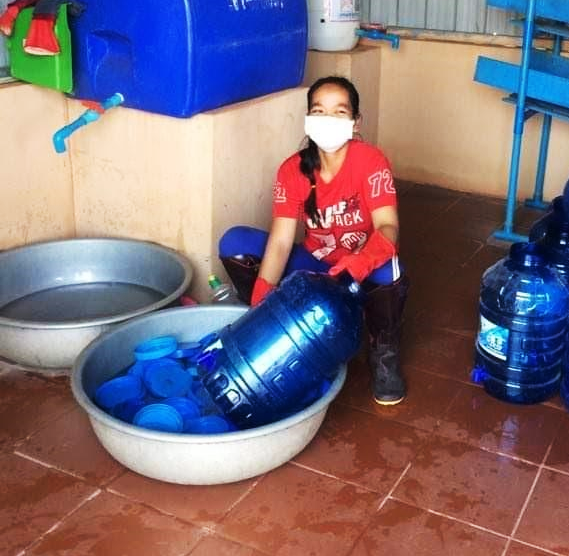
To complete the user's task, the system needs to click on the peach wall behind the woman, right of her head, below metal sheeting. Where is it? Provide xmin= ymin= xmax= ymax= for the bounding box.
xmin=307 ymin=38 xmax=569 ymax=199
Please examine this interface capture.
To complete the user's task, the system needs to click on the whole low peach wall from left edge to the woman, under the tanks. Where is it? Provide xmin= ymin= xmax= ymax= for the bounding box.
xmin=0 ymin=83 xmax=306 ymax=301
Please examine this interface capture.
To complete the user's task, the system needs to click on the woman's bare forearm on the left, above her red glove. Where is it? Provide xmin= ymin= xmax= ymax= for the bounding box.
xmin=259 ymin=216 xmax=297 ymax=285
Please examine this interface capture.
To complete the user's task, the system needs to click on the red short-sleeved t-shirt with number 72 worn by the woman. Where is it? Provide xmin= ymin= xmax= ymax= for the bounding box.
xmin=273 ymin=140 xmax=397 ymax=264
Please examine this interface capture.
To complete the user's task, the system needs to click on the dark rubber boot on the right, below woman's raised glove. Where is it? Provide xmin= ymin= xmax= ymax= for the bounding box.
xmin=365 ymin=276 xmax=409 ymax=405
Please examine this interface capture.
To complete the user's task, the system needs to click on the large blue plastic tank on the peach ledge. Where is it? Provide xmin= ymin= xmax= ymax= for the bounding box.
xmin=70 ymin=0 xmax=307 ymax=117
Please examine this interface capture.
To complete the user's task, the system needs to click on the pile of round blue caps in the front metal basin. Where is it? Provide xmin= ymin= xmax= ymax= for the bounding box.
xmin=95 ymin=336 xmax=232 ymax=434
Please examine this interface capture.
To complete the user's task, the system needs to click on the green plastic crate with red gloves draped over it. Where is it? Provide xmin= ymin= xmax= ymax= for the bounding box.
xmin=8 ymin=4 xmax=73 ymax=93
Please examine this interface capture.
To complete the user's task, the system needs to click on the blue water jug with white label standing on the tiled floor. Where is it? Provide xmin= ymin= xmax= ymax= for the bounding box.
xmin=472 ymin=243 xmax=569 ymax=404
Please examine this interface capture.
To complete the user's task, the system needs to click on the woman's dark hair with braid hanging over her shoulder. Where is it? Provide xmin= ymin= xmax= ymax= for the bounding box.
xmin=299 ymin=75 xmax=360 ymax=227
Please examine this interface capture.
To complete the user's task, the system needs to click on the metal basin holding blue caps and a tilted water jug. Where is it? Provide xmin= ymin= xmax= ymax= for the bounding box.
xmin=71 ymin=305 xmax=346 ymax=485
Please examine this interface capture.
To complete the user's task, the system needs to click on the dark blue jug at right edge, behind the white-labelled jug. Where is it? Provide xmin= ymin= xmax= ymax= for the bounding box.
xmin=529 ymin=182 xmax=569 ymax=286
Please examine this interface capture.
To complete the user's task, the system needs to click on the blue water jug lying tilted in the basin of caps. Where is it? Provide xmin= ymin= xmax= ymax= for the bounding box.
xmin=198 ymin=271 xmax=363 ymax=428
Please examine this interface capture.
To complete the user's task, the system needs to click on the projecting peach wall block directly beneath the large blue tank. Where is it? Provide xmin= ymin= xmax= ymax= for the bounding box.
xmin=69 ymin=88 xmax=306 ymax=301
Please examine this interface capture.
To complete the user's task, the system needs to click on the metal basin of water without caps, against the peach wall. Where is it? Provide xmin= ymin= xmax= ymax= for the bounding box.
xmin=0 ymin=238 xmax=192 ymax=368
